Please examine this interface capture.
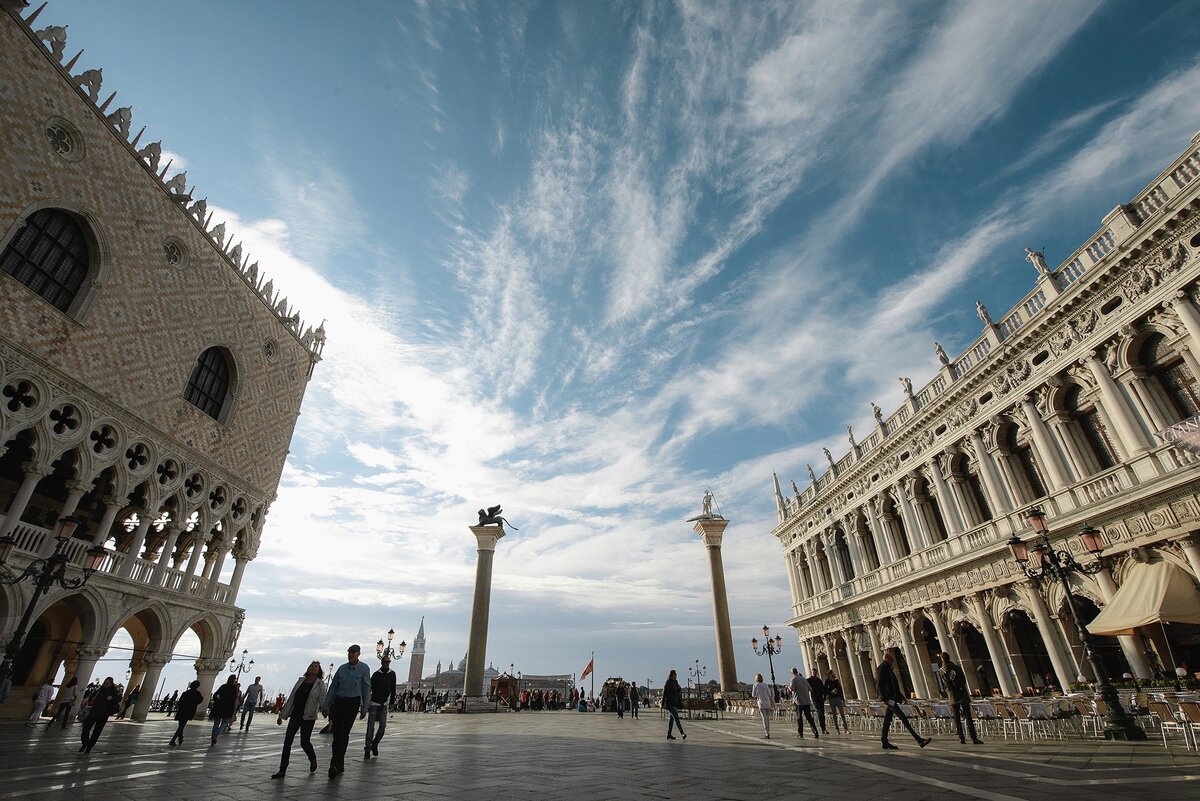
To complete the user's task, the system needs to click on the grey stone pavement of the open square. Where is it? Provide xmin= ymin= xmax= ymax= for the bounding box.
xmin=0 ymin=710 xmax=1200 ymax=801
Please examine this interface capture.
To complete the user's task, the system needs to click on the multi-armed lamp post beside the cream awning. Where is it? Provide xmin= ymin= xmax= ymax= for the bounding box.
xmin=1008 ymin=506 xmax=1146 ymax=740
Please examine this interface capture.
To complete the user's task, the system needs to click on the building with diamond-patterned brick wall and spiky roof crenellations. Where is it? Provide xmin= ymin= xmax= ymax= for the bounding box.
xmin=0 ymin=0 xmax=324 ymax=719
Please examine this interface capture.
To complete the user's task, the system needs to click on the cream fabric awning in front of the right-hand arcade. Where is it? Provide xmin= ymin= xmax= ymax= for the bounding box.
xmin=1087 ymin=560 xmax=1200 ymax=636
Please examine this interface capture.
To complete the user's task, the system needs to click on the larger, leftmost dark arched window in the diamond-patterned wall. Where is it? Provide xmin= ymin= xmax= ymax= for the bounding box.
xmin=0 ymin=209 xmax=91 ymax=312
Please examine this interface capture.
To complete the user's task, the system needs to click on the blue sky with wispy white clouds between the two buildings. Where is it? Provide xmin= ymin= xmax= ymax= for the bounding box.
xmin=38 ymin=0 xmax=1200 ymax=686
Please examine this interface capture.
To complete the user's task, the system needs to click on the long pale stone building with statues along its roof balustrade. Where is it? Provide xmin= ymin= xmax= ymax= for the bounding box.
xmin=774 ymin=134 xmax=1200 ymax=698
